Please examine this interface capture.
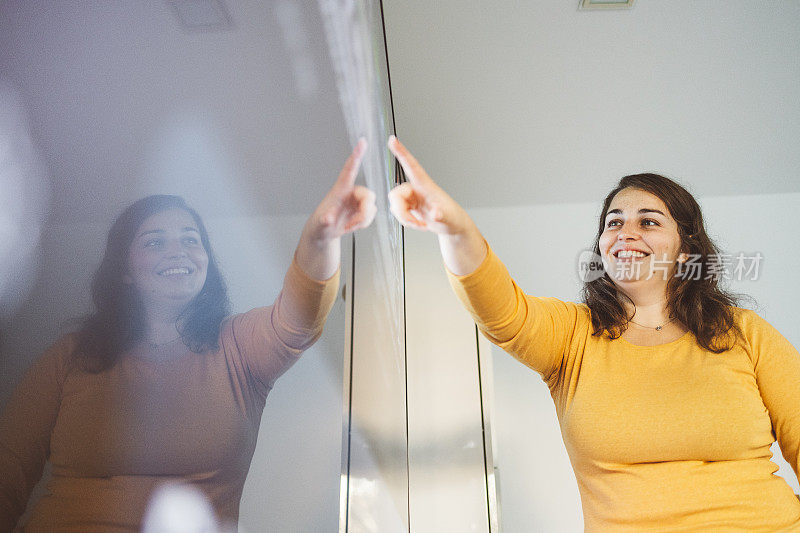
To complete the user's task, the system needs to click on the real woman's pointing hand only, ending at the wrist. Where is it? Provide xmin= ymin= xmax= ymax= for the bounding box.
xmin=388 ymin=135 xmax=471 ymax=235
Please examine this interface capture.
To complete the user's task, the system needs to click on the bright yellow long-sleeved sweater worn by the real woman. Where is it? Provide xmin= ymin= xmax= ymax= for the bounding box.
xmin=450 ymin=250 xmax=800 ymax=532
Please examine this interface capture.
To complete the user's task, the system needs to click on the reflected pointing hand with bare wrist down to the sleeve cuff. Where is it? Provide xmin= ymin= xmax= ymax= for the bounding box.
xmin=296 ymin=138 xmax=378 ymax=280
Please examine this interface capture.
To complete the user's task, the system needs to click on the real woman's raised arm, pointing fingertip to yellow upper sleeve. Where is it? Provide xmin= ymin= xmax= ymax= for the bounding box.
xmin=389 ymin=137 xmax=588 ymax=381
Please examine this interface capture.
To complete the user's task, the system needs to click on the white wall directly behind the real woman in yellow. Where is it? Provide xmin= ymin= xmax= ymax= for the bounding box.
xmin=470 ymin=190 xmax=800 ymax=533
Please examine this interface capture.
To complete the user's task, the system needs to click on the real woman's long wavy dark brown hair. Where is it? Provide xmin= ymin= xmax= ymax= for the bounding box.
xmin=582 ymin=174 xmax=739 ymax=353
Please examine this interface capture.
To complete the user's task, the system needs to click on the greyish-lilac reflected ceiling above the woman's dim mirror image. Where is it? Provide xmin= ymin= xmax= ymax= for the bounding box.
xmin=0 ymin=0 xmax=349 ymax=224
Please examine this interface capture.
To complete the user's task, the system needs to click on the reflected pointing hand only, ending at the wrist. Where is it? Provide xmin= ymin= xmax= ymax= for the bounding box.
xmin=308 ymin=138 xmax=377 ymax=241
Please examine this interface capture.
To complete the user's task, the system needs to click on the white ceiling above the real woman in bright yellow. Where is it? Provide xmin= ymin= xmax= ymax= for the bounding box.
xmin=383 ymin=0 xmax=800 ymax=206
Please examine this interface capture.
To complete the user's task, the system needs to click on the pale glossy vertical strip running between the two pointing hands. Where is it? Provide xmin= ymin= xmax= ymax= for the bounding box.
xmin=320 ymin=0 xmax=409 ymax=532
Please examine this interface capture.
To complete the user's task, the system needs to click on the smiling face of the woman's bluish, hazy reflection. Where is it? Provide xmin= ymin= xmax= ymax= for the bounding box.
xmin=123 ymin=208 xmax=208 ymax=310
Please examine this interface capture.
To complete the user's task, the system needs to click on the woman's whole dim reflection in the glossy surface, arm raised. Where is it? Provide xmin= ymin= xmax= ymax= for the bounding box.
xmin=0 ymin=141 xmax=375 ymax=531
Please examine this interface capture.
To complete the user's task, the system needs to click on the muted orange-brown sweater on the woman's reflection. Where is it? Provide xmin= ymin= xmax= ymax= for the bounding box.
xmin=0 ymin=263 xmax=339 ymax=533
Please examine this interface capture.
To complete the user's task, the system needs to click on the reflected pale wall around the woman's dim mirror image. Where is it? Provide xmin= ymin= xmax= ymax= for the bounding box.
xmin=0 ymin=213 xmax=344 ymax=532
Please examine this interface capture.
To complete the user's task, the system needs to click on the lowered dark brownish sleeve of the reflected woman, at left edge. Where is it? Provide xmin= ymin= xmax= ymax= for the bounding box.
xmin=0 ymin=336 xmax=74 ymax=532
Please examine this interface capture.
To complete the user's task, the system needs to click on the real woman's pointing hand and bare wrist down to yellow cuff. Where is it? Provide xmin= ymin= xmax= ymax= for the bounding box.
xmin=388 ymin=135 xmax=486 ymax=275
